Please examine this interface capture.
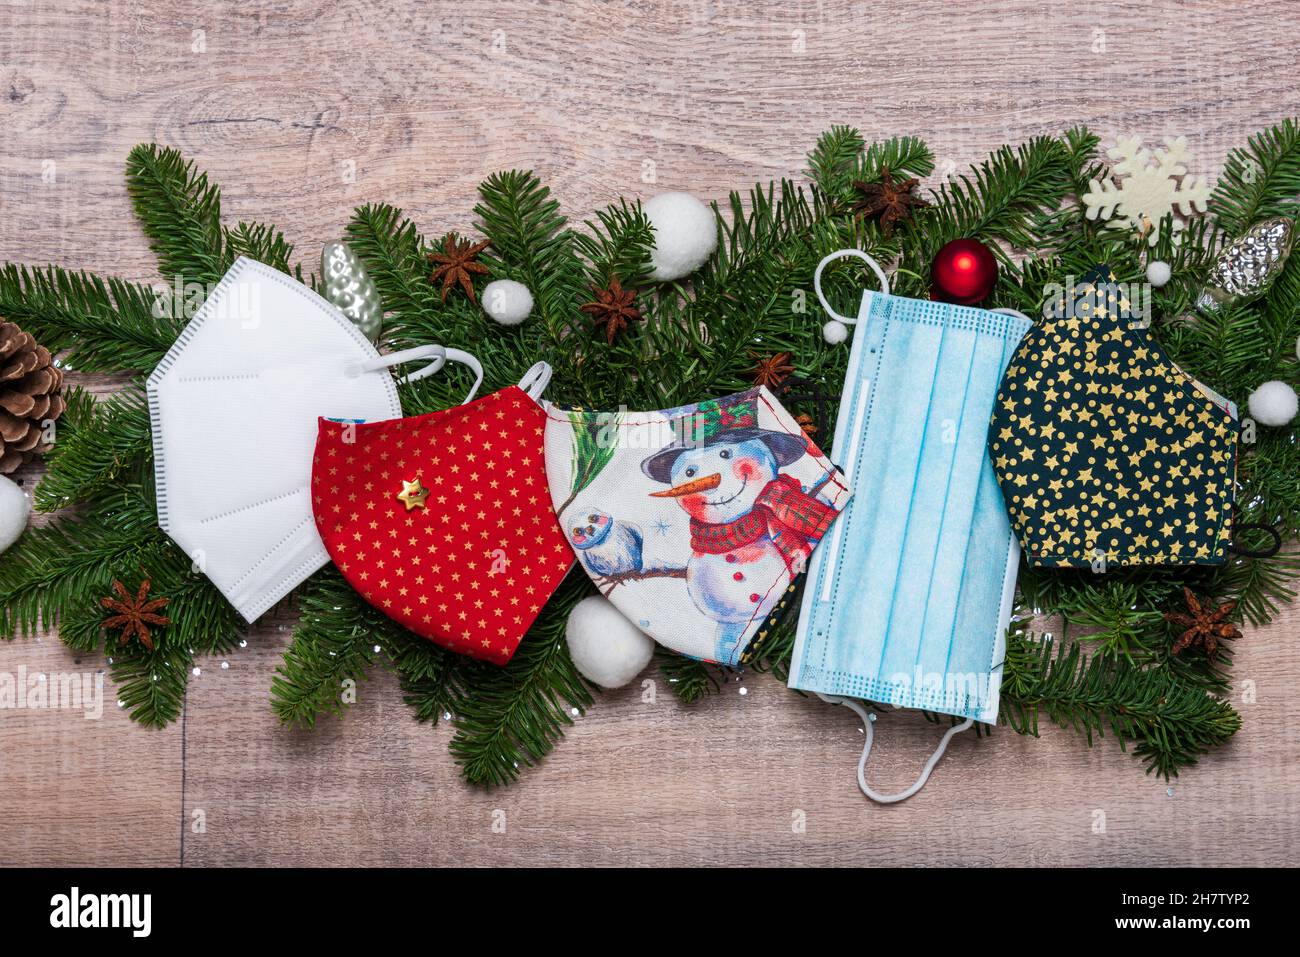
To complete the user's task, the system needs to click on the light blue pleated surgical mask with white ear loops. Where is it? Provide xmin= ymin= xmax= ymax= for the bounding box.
xmin=789 ymin=250 xmax=1032 ymax=802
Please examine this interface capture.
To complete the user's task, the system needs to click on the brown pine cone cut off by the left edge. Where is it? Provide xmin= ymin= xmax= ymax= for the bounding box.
xmin=0 ymin=321 xmax=64 ymax=475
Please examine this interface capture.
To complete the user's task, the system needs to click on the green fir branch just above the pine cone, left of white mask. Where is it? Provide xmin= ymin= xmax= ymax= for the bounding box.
xmin=0 ymin=263 xmax=185 ymax=373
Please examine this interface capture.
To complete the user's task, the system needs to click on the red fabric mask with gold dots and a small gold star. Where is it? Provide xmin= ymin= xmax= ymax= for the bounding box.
xmin=312 ymin=350 xmax=573 ymax=664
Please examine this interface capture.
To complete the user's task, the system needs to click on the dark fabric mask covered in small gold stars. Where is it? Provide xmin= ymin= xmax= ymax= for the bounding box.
xmin=988 ymin=267 xmax=1238 ymax=568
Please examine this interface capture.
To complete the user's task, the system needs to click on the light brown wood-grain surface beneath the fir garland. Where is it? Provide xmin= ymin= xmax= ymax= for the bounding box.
xmin=0 ymin=0 xmax=1300 ymax=865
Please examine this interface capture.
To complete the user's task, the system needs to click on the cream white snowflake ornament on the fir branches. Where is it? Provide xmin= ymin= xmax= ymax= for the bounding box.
xmin=1083 ymin=137 xmax=1210 ymax=246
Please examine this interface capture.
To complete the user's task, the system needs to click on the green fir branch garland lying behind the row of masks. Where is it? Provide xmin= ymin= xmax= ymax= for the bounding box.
xmin=0 ymin=121 xmax=1300 ymax=784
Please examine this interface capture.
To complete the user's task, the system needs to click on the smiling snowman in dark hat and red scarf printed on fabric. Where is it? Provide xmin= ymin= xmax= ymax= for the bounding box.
xmin=641 ymin=394 xmax=836 ymax=663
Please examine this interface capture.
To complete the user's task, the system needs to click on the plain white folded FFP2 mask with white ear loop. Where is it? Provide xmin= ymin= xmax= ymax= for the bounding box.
xmin=148 ymin=259 xmax=460 ymax=622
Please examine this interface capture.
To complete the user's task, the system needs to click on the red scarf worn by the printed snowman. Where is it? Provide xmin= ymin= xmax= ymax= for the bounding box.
xmin=690 ymin=475 xmax=837 ymax=564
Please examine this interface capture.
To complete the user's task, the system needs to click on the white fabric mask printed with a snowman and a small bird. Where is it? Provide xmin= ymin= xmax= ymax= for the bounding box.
xmin=545 ymin=386 xmax=849 ymax=666
